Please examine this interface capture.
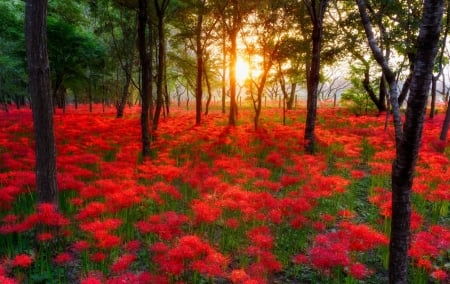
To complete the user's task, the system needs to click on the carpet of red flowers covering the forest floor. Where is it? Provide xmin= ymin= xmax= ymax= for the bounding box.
xmin=0 ymin=106 xmax=450 ymax=284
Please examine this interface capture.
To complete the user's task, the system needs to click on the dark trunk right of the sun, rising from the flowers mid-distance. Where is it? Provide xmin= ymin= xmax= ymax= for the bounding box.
xmin=304 ymin=0 xmax=328 ymax=154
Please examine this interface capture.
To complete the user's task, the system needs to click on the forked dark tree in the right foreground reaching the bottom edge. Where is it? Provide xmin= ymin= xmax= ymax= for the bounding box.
xmin=356 ymin=0 xmax=444 ymax=283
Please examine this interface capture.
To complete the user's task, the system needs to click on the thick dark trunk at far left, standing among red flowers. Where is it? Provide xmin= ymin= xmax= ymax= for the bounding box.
xmin=25 ymin=0 xmax=58 ymax=208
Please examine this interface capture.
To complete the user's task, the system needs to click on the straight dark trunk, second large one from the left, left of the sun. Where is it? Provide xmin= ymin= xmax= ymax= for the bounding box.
xmin=138 ymin=0 xmax=151 ymax=159
